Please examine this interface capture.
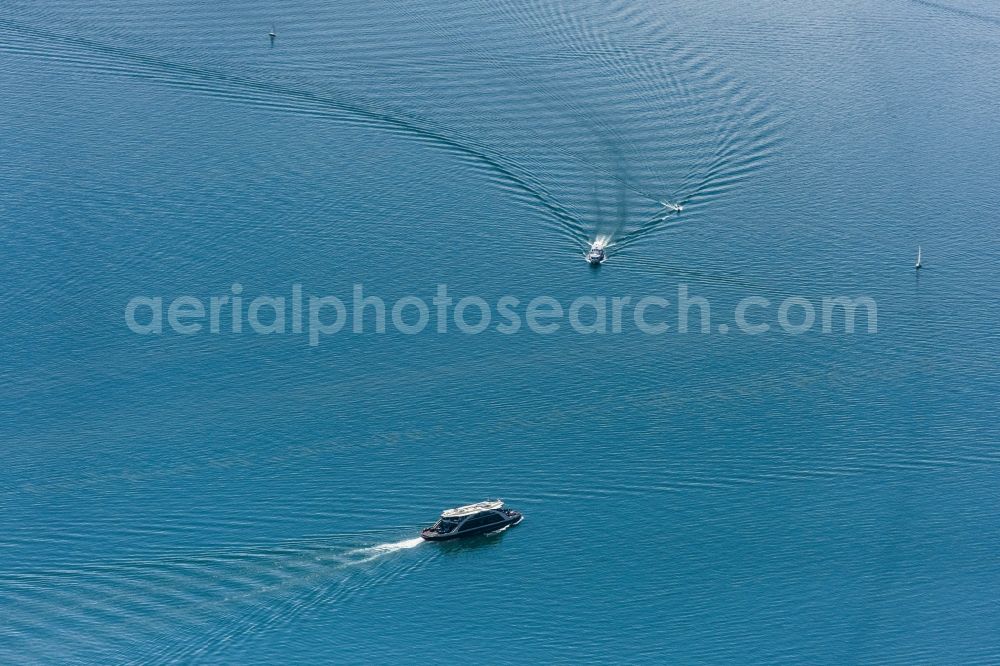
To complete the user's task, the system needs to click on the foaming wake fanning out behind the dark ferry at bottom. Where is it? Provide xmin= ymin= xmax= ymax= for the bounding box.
xmin=0 ymin=537 xmax=433 ymax=661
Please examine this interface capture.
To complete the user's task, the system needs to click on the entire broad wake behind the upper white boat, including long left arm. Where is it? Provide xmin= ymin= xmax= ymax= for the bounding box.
xmin=0 ymin=0 xmax=778 ymax=260
